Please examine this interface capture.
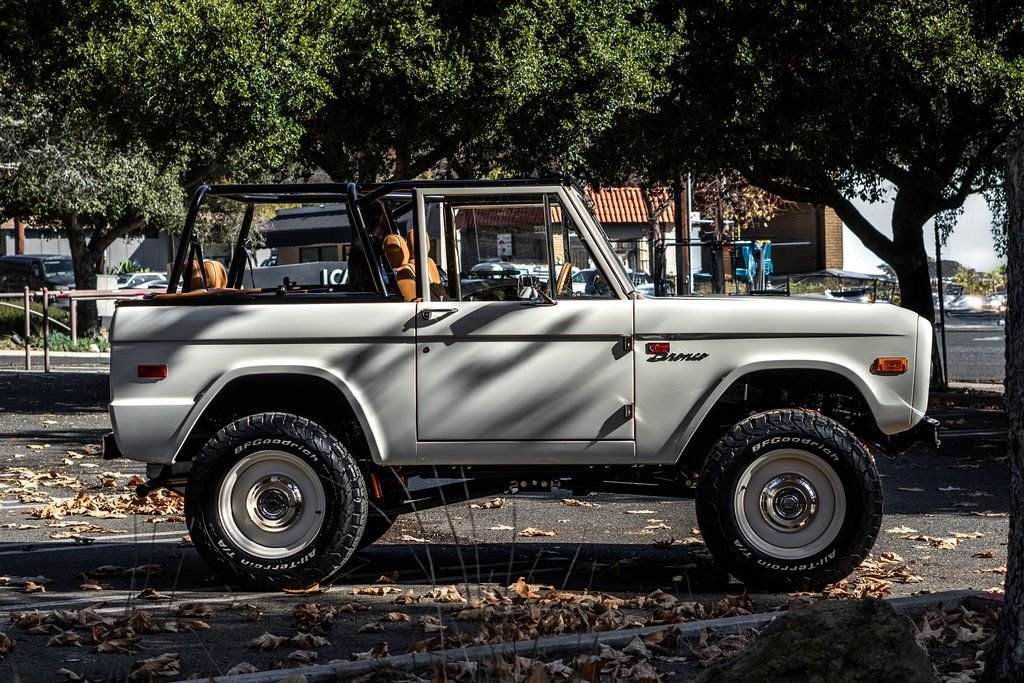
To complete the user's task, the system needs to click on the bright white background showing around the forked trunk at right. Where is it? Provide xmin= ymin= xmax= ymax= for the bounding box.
xmin=843 ymin=195 xmax=1006 ymax=272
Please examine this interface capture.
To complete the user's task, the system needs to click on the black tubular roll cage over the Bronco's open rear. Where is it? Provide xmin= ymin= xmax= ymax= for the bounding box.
xmin=167 ymin=177 xmax=586 ymax=297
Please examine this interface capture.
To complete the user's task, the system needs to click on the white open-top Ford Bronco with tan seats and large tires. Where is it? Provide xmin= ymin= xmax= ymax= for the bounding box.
xmin=103 ymin=180 xmax=935 ymax=589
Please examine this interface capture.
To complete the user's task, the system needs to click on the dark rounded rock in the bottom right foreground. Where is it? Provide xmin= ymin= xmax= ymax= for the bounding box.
xmin=699 ymin=600 xmax=936 ymax=683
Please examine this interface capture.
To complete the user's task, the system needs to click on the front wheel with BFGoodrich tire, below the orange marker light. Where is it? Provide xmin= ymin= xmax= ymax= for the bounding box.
xmin=696 ymin=410 xmax=882 ymax=590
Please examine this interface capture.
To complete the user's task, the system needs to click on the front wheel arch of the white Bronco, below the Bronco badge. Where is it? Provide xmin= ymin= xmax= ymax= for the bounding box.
xmin=677 ymin=360 xmax=881 ymax=473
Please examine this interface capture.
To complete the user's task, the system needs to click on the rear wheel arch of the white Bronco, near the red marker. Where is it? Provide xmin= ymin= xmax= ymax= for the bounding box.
xmin=174 ymin=366 xmax=382 ymax=462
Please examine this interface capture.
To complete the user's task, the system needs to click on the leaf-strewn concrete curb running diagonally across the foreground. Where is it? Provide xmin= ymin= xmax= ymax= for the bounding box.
xmin=179 ymin=591 xmax=988 ymax=683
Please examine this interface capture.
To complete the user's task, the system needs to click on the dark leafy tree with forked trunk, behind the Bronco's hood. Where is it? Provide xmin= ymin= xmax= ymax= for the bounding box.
xmin=594 ymin=0 xmax=1024 ymax=319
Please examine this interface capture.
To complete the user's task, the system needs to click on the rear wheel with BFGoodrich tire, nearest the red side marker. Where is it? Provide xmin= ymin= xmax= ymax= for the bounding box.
xmin=185 ymin=413 xmax=368 ymax=590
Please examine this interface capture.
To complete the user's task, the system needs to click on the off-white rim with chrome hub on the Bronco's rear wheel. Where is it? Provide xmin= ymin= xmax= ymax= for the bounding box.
xmin=217 ymin=451 xmax=327 ymax=560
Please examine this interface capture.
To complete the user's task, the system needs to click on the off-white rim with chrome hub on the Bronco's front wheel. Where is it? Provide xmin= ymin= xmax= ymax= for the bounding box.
xmin=734 ymin=449 xmax=846 ymax=560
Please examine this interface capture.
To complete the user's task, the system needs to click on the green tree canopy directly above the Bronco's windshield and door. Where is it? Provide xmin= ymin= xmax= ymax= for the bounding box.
xmin=306 ymin=0 xmax=679 ymax=181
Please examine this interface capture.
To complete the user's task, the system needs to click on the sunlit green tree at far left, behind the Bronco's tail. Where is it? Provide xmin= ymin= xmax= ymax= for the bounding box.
xmin=0 ymin=0 xmax=333 ymax=330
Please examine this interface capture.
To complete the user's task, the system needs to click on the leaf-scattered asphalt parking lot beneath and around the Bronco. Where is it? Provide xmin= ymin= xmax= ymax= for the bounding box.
xmin=0 ymin=370 xmax=1008 ymax=681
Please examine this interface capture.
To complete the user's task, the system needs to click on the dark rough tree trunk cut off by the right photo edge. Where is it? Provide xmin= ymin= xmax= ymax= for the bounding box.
xmin=984 ymin=125 xmax=1024 ymax=681
